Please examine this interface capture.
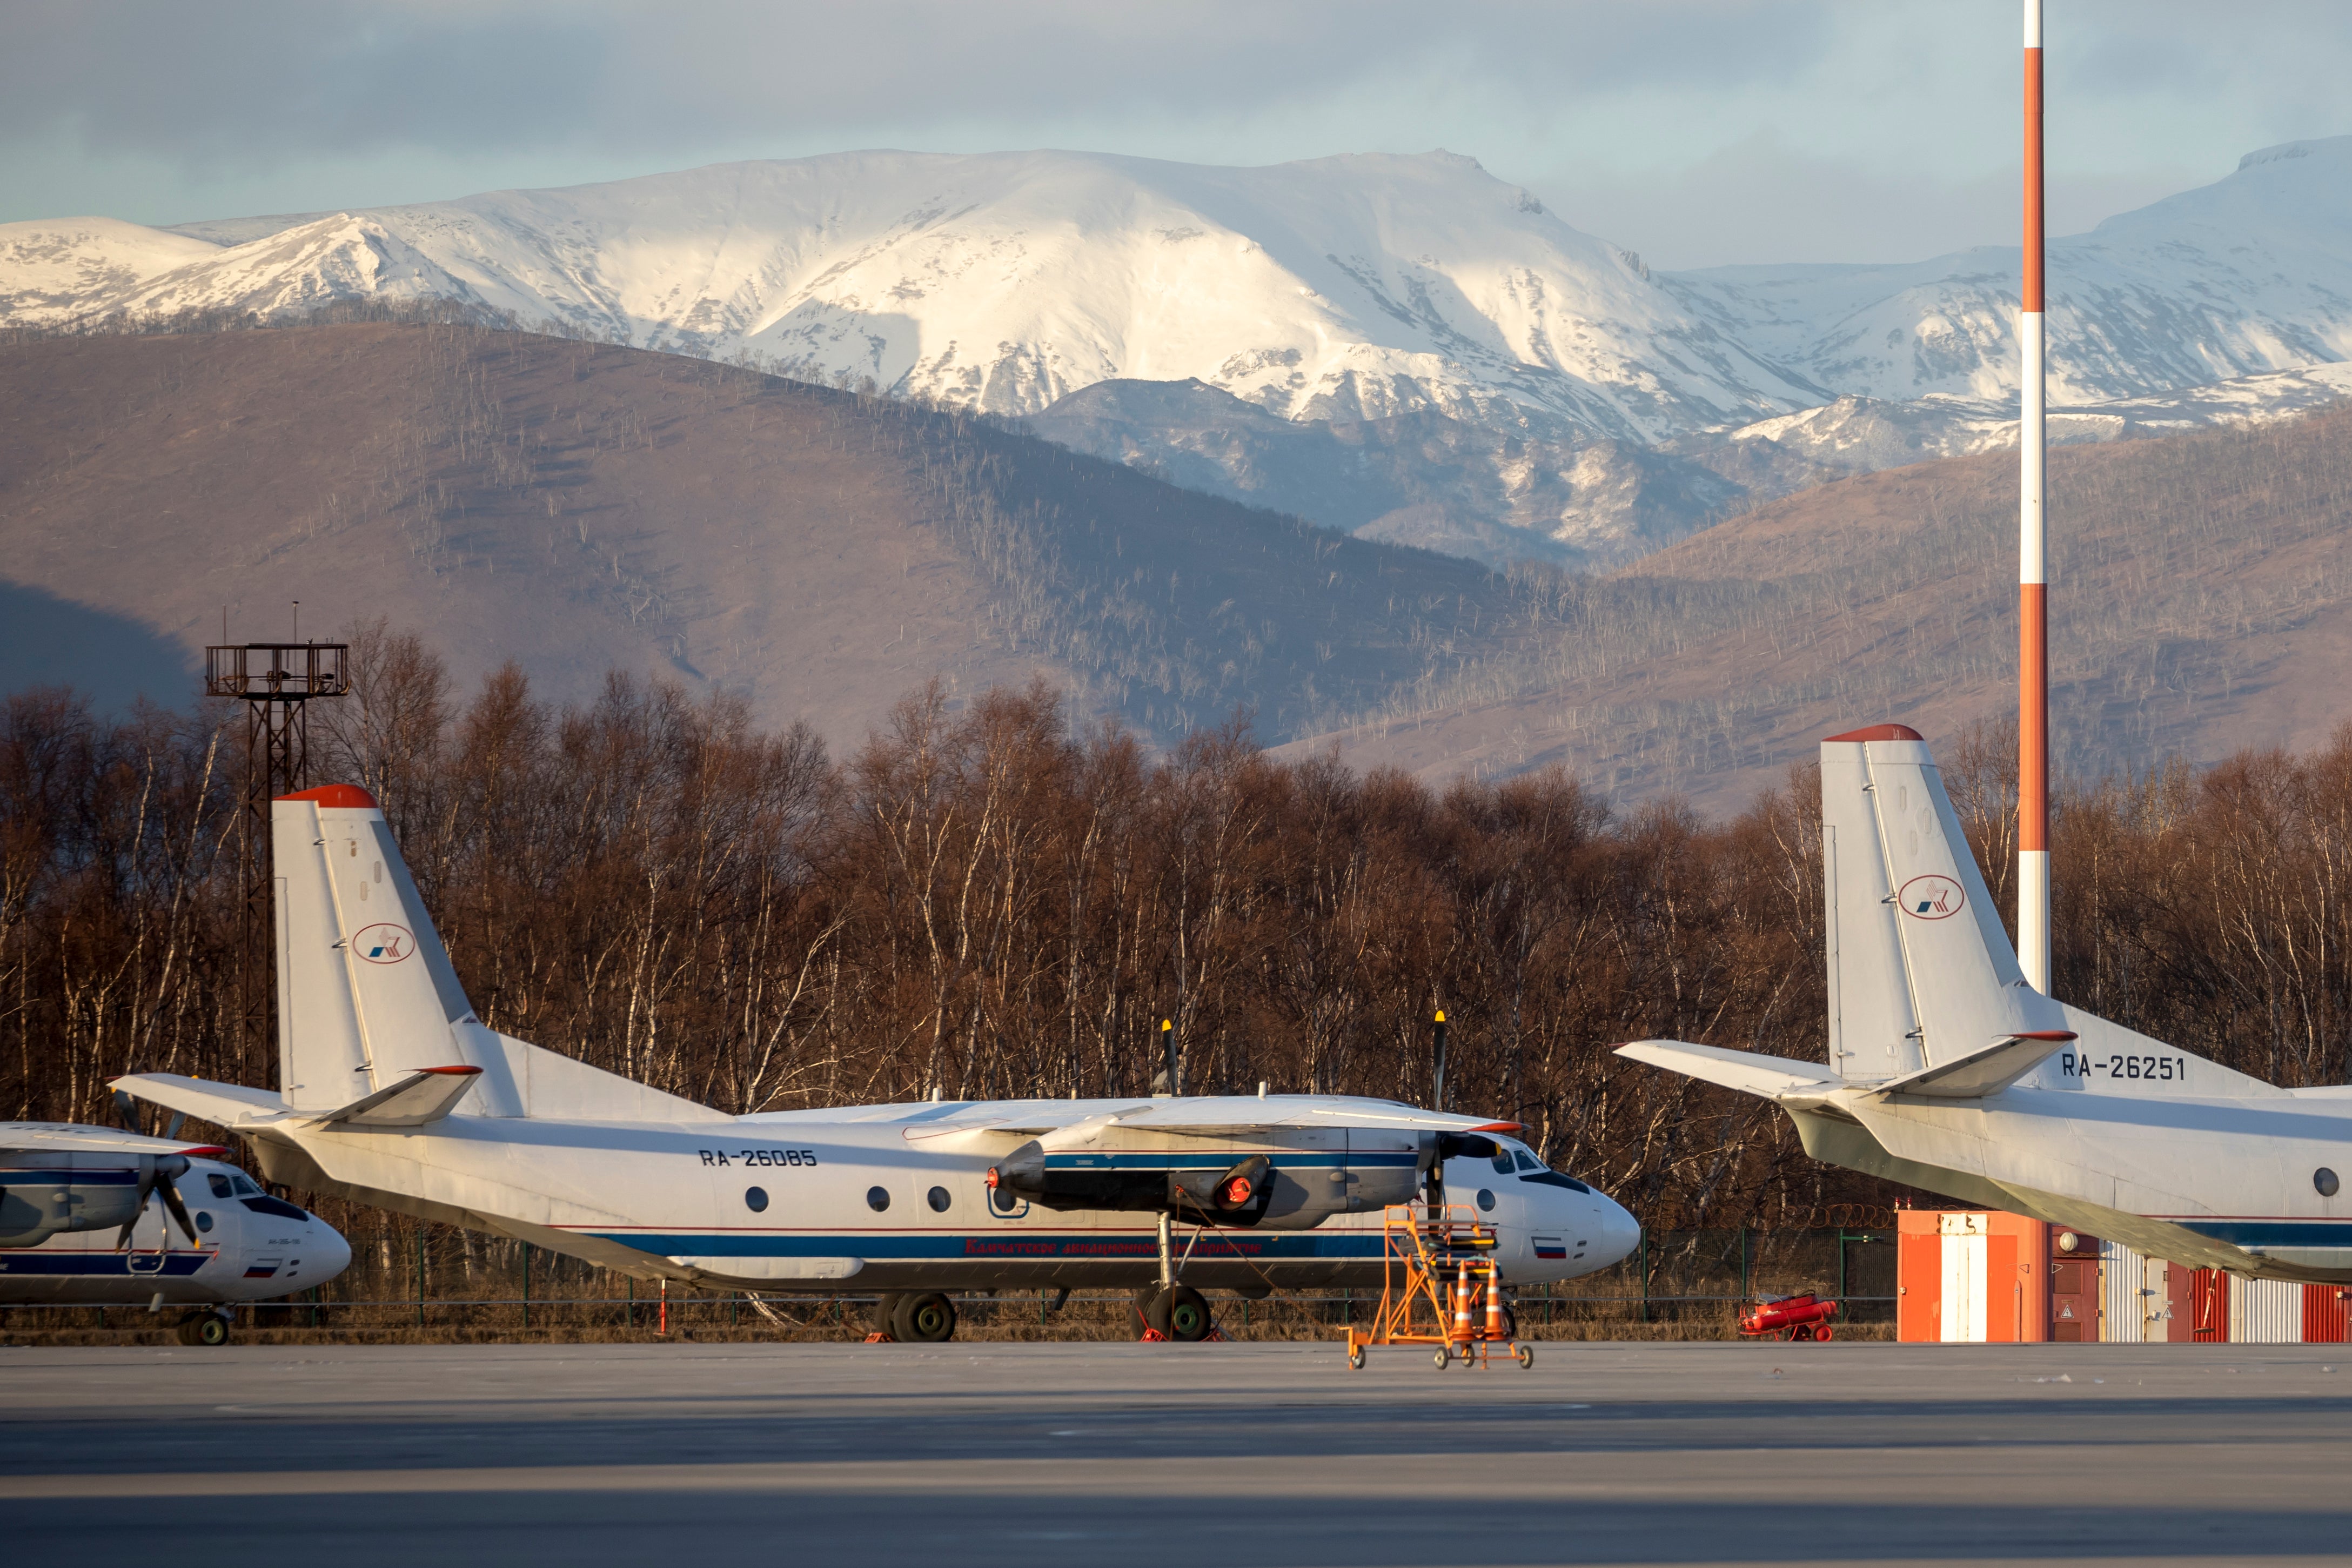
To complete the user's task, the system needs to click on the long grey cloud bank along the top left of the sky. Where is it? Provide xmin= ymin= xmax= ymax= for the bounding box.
xmin=0 ymin=0 xmax=1818 ymax=162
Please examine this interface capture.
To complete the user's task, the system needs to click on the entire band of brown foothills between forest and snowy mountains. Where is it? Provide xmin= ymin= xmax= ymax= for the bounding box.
xmin=0 ymin=322 xmax=2352 ymax=806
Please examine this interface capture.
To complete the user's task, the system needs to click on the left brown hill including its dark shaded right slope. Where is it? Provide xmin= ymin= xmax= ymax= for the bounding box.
xmin=0 ymin=322 xmax=1503 ymax=743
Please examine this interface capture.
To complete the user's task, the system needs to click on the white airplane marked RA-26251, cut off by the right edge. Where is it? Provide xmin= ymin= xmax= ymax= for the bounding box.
xmin=1618 ymin=724 xmax=2352 ymax=1284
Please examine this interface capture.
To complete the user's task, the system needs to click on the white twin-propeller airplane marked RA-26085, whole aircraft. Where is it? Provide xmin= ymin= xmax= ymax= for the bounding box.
xmin=118 ymin=785 xmax=1639 ymax=1340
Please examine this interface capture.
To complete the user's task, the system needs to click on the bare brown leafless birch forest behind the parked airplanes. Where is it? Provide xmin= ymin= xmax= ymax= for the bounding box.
xmin=0 ymin=628 xmax=2352 ymax=1227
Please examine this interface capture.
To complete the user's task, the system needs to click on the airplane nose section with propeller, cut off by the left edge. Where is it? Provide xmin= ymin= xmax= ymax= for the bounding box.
xmin=0 ymin=1121 xmax=351 ymax=1345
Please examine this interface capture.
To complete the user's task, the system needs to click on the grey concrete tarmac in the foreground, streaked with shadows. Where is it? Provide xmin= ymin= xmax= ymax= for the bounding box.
xmin=0 ymin=1342 xmax=2352 ymax=1568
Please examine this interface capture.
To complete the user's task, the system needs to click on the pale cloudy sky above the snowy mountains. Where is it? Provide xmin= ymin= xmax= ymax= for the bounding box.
xmin=0 ymin=0 xmax=2352 ymax=268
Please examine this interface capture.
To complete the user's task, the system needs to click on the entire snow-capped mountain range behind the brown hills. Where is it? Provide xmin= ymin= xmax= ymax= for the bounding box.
xmin=14 ymin=136 xmax=2352 ymax=567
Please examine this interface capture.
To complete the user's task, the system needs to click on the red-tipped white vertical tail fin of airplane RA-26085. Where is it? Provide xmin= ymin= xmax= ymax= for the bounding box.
xmin=271 ymin=785 xmax=713 ymax=1124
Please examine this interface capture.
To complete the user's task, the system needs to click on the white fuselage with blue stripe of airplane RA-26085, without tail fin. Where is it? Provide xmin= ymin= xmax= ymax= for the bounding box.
xmin=238 ymin=1100 xmax=1639 ymax=1293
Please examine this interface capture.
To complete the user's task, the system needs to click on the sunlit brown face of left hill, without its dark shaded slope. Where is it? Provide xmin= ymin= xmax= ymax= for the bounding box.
xmin=0 ymin=324 xmax=1037 ymax=731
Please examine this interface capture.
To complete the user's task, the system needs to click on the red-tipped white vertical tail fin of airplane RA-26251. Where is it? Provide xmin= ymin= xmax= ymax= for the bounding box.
xmin=1820 ymin=724 xmax=2067 ymax=1084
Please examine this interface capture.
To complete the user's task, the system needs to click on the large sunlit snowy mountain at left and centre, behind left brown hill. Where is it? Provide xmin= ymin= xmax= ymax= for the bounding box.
xmin=0 ymin=153 xmax=1823 ymax=440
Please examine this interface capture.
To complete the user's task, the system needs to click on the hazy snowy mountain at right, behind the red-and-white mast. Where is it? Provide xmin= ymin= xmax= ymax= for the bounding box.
xmin=1660 ymin=136 xmax=2352 ymax=404
